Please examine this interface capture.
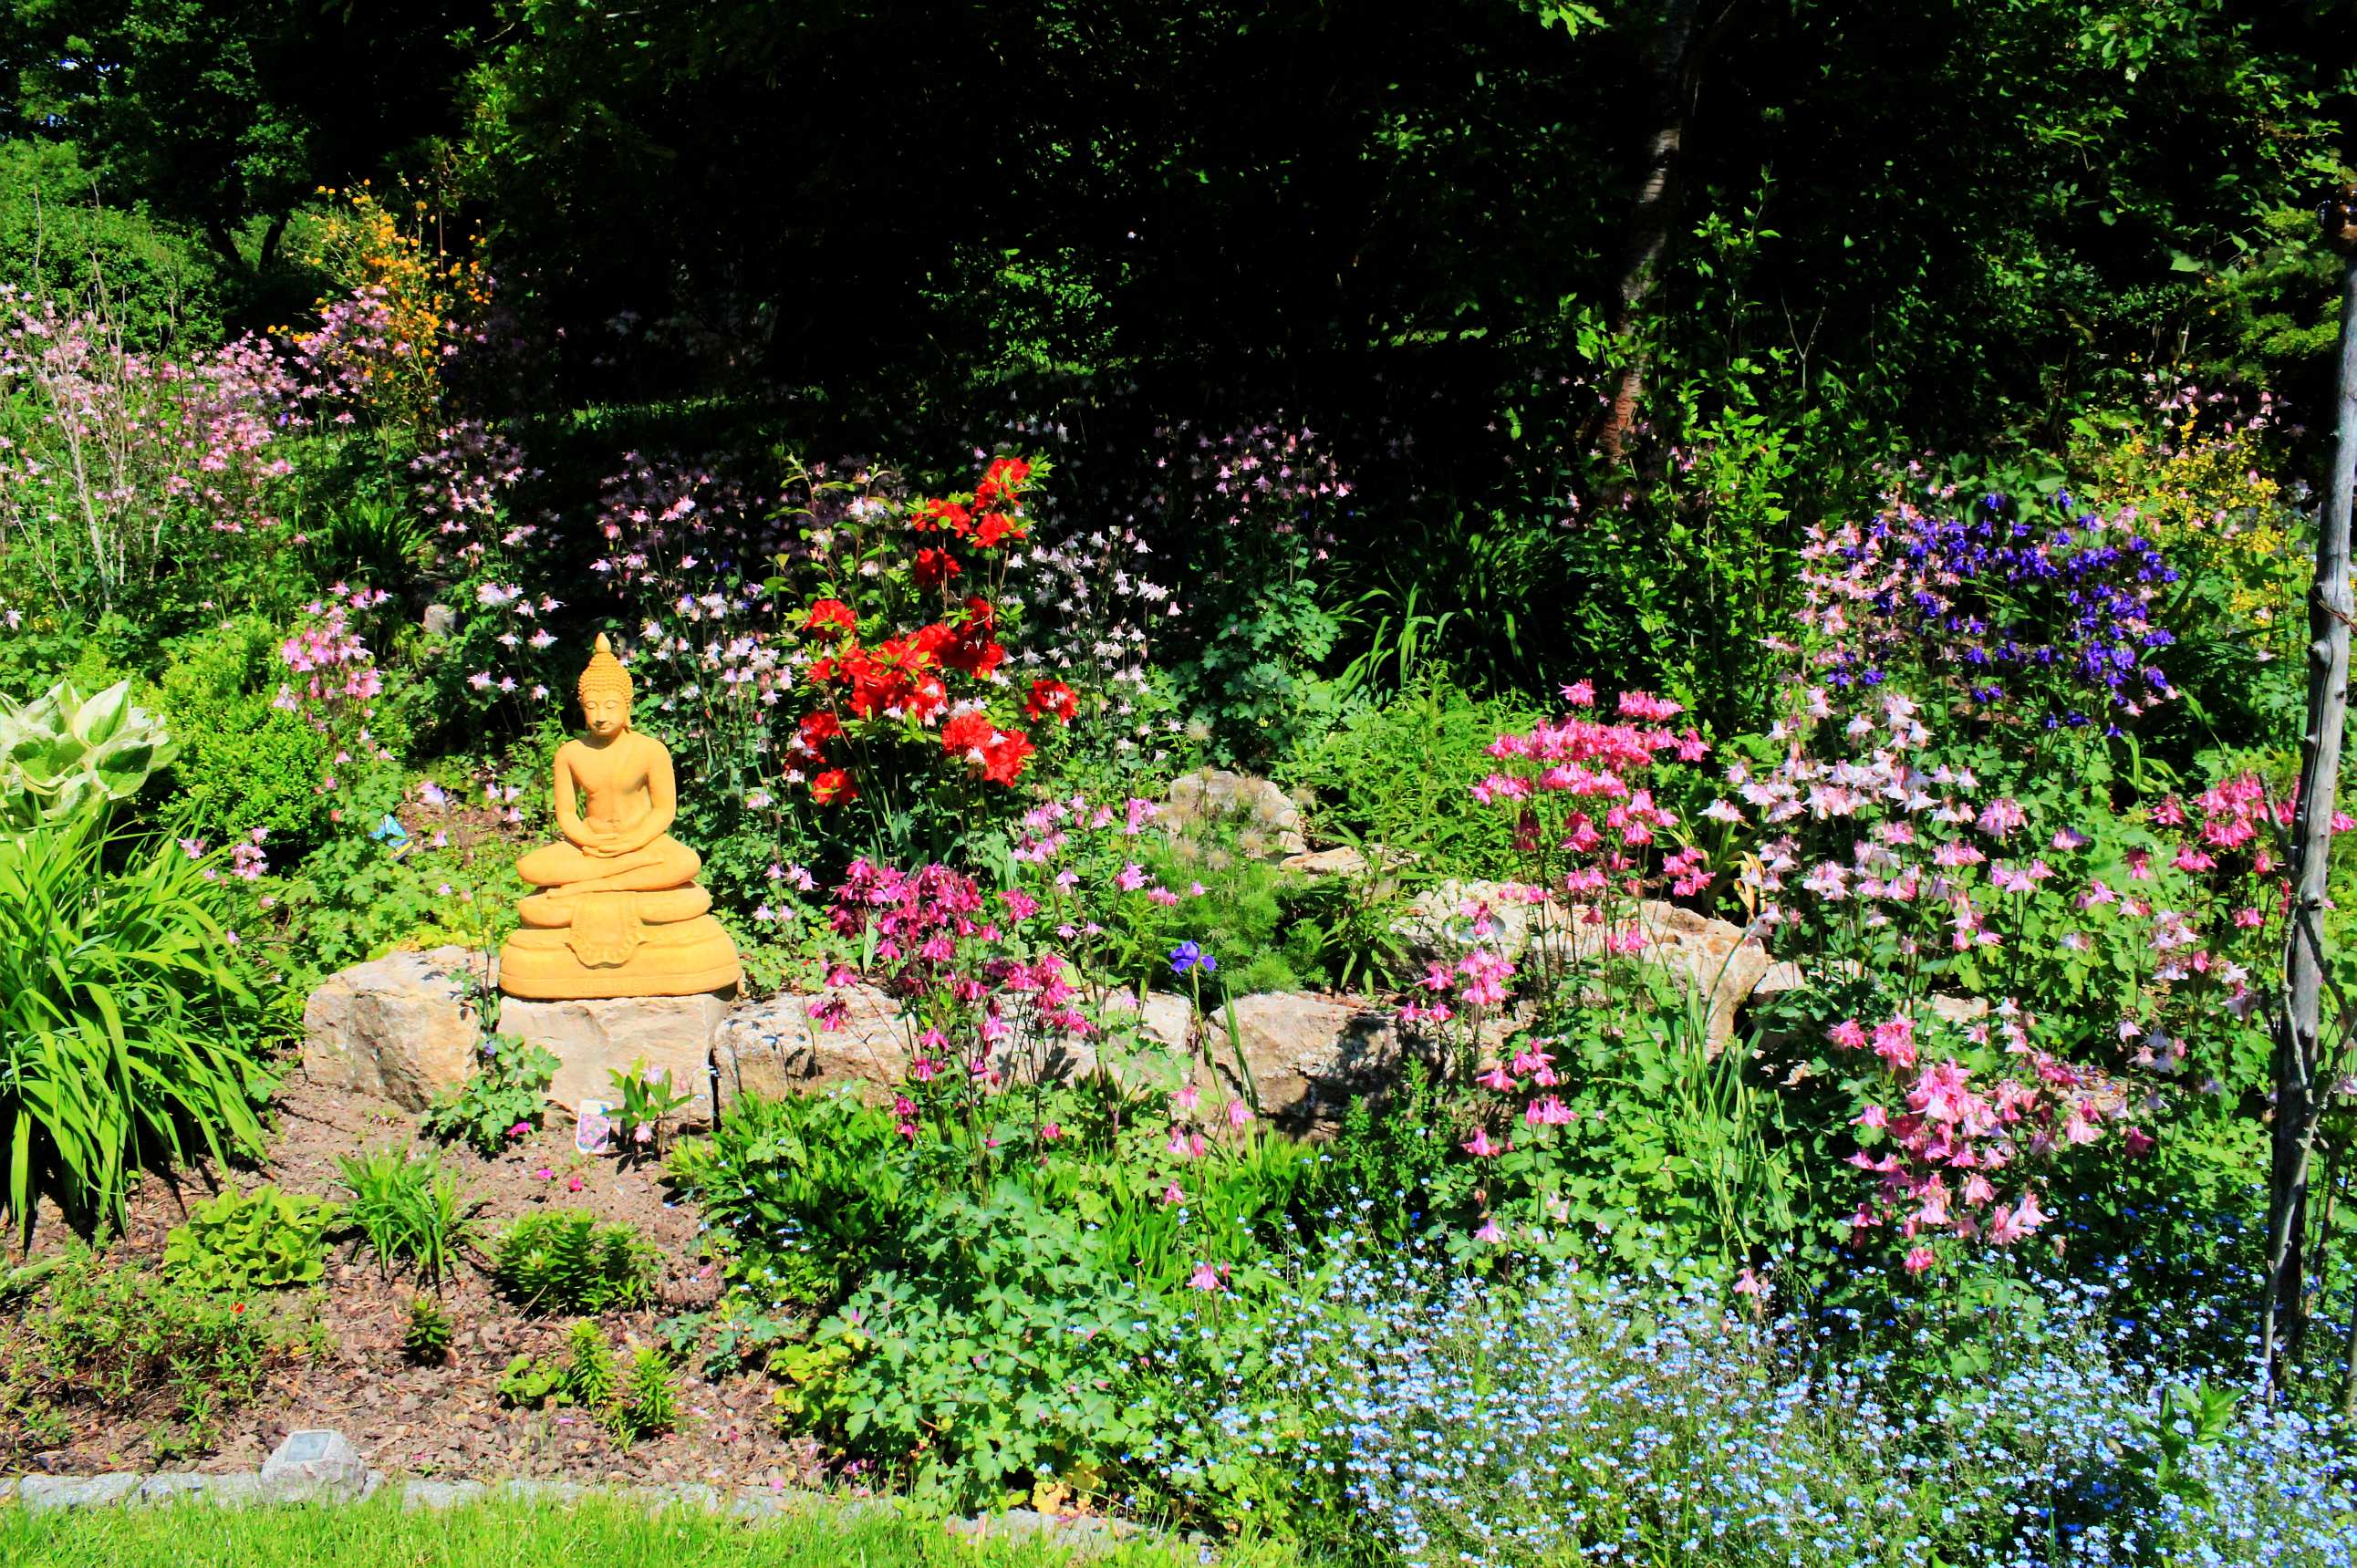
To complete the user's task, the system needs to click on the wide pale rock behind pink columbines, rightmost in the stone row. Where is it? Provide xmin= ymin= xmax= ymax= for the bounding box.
xmin=1393 ymin=877 xmax=1770 ymax=1047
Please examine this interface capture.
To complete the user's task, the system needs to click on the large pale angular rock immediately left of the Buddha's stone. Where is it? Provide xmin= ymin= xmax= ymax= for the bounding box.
xmin=302 ymin=948 xmax=481 ymax=1111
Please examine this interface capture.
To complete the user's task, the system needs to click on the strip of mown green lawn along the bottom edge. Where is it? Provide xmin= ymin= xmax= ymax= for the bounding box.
xmin=0 ymin=1497 xmax=1296 ymax=1568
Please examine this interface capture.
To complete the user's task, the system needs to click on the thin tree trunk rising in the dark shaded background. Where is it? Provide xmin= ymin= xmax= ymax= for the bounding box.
xmin=1598 ymin=0 xmax=1742 ymax=460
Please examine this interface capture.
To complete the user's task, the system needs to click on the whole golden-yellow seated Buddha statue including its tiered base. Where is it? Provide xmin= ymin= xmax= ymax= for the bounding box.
xmin=500 ymin=634 xmax=738 ymax=1002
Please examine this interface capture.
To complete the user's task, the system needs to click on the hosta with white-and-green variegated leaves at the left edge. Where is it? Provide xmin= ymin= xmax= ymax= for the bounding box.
xmin=0 ymin=681 xmax=174 ymax=832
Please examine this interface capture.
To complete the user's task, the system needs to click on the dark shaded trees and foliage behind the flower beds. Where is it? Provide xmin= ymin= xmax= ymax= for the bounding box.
xmin=0 ymin=0 xmax=2357 ymax=726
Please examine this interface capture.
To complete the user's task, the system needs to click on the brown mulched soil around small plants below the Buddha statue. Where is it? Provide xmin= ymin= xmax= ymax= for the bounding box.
xmin=9 ymin=1073 xmax=818 ymax=1486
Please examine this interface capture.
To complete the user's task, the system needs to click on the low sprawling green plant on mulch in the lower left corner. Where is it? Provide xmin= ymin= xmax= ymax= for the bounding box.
xmin=0 ymin=1252 xmax=316 ymax=1464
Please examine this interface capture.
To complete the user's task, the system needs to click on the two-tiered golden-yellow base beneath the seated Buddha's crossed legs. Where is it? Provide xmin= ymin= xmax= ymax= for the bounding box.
xmin=500 ymin=887 xmax=738 ymax=1002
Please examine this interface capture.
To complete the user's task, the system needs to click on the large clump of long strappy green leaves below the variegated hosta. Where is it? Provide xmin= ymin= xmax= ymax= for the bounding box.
xmin=0 ymin=818 xmax=271 ymax=1226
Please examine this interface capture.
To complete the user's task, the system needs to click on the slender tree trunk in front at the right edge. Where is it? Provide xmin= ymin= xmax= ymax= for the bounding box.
xmin=2260 ymin=202 xmax=2357 ymax=1389
